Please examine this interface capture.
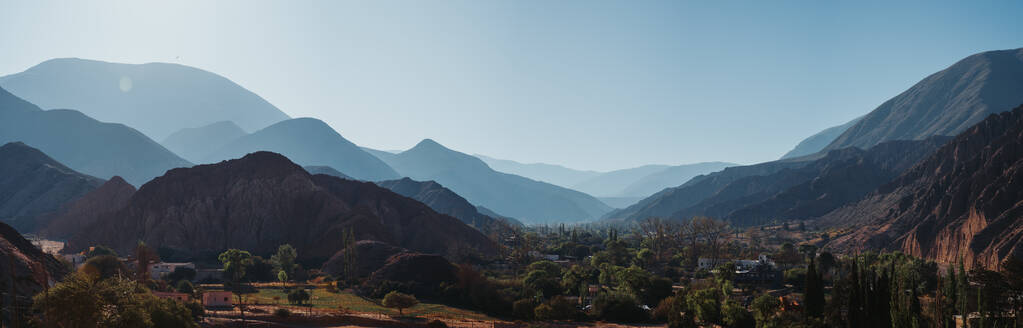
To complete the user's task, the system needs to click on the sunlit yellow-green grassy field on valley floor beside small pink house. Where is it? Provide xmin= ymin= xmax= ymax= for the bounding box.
xmin=250 ymin=288 xmax=494 ymax=321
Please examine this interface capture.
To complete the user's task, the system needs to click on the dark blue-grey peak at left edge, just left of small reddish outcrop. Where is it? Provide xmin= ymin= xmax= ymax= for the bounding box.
xmin=0 ymin=142 xmax=103 ymax=232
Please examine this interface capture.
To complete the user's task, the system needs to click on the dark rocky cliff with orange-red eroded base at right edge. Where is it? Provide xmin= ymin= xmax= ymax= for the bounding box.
xmin=822 ymin=106 xmax=1023 ymax=269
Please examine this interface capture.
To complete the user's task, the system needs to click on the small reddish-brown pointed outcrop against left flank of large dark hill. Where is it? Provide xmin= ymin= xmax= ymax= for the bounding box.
xmin=37 ymin=177 xmax=135 ymax=240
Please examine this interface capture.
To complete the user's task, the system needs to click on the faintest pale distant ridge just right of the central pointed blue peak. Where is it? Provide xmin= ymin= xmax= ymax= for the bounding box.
xmin=475 ymin=154 xmax=601 ymax=188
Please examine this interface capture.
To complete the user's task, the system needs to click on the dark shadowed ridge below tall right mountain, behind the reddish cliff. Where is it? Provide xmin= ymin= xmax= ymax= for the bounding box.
xmin=672 ymin=137 xmax=949 ymax=226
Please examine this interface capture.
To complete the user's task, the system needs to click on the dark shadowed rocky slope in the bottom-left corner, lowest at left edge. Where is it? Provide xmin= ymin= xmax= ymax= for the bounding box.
xmin=0 ymin=219 xmax=69 ymax=318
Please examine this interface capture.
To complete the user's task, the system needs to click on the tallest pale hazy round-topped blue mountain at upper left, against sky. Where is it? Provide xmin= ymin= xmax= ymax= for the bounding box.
xmin=0 ymin=58 xmax=288 ymax=140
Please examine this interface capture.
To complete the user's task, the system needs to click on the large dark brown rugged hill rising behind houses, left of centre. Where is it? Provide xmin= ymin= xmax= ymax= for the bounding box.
xmin=69 ymin=152 xmax=496 ymax=260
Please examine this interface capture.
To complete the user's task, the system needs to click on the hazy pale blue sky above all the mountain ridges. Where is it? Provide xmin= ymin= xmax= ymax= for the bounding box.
xmin=0 ymin=0 xmax=1023 ymax=170
